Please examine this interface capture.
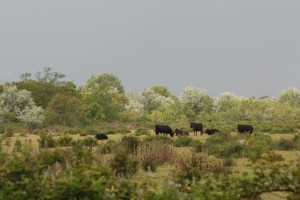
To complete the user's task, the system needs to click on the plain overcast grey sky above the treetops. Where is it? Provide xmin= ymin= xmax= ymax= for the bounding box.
xmin=0 ymin=0 xmax=300 ymax=97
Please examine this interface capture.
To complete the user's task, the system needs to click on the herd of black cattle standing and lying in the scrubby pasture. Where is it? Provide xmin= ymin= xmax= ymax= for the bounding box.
xmin=95 ymin=122 xmax=253 ymax=140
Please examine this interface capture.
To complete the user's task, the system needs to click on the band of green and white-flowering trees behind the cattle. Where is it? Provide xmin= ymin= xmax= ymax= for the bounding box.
xmin=0 ymin=67 xmax=300 ymax=132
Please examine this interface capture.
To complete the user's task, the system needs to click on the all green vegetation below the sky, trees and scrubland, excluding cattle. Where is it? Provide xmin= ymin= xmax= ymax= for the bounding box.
xmin=0 ymin=67 xmax=300 ymax=199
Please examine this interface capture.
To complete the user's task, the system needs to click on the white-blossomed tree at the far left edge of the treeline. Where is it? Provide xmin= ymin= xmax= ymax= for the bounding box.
xmin=0 ymin=86 xmax=44 ymax=129
